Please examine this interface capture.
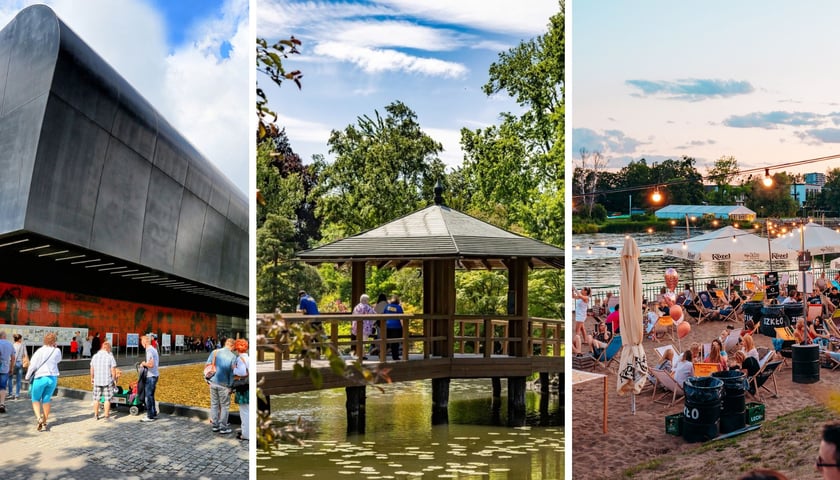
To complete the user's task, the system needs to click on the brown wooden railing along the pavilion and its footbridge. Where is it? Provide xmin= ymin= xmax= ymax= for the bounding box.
xmin=257 ymin=313 xmax=564 ymax=370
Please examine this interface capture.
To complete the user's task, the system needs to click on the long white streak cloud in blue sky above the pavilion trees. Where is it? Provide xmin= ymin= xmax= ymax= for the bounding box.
xmin=315 ymin=42 xmax=468 ymax=78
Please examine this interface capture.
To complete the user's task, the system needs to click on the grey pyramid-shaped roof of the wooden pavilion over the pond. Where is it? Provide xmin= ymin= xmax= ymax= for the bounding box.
xmin=297 ymin=205 xmax=564 ymax=270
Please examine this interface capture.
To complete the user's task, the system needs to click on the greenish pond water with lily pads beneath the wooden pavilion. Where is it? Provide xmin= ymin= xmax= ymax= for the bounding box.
xmin=257 ymin=379 xmax=565 ymax=480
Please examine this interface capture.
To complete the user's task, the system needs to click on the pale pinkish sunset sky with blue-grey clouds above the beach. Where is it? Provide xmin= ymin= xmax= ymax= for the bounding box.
xmin=567 ymin=0 xmax=840 ymax=178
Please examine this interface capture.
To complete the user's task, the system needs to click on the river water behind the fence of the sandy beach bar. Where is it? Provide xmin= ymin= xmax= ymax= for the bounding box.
xmin=572 ymin=230 xmax=820 ymax=290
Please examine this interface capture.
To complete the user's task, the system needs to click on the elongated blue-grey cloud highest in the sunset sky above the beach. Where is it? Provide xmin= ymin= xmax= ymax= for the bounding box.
xmin=624 ymin=78 xmax=755 ymax=102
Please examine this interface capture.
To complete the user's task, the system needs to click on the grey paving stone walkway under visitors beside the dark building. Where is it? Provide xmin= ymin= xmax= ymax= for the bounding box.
xmin=0 ymin=395 xmax=249 ymax=480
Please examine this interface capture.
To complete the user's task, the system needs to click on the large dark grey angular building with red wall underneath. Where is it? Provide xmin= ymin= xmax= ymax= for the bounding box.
xmin=0 ymin=5 xmax=249 ymax=344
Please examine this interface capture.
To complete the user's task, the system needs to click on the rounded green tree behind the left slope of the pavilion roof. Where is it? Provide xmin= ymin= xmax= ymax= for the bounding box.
xmin=313 ymin=101 xmax=444 ymax=237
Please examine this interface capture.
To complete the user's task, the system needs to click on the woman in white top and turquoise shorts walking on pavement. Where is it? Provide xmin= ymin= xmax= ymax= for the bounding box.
xmin=26 ymin=333 xmax=61 ymax=431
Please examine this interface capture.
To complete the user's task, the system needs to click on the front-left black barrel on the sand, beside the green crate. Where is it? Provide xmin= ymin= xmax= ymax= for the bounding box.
xmin=683 ymin=377 xmax=723 ymax=443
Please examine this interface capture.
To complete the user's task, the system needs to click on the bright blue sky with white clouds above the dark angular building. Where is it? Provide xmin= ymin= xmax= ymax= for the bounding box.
xmin=0 ymin=0 xmax=249 ymax=192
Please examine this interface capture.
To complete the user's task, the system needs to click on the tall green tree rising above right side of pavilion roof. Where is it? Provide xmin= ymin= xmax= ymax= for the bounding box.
xmin=461 ymin=2 xmax=565 ymax=244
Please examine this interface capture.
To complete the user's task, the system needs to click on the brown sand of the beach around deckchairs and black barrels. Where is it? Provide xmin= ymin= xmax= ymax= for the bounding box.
xmin=572 ymin=319 xmax=840 ymax=479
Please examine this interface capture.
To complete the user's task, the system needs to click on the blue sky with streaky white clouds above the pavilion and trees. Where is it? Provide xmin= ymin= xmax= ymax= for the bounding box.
xmin=257 ymin=0 xmax=560 ymax=171
